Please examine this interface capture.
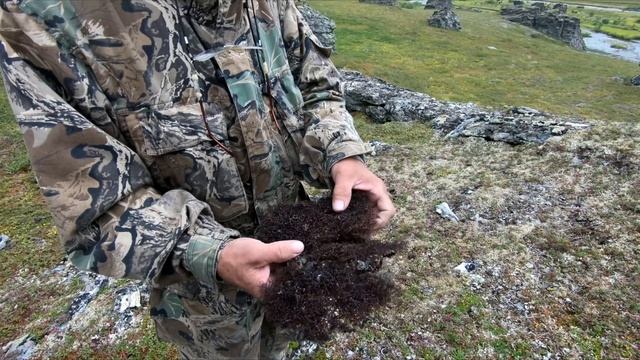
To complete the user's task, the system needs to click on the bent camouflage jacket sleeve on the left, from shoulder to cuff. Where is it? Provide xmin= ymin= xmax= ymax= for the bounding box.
xmin=0 ymin=12 xmax=239 ymax=287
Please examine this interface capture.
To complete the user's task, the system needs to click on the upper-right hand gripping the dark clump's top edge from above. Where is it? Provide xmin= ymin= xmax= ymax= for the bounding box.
xmin=331 ymin=158 xmax=396 ymax=230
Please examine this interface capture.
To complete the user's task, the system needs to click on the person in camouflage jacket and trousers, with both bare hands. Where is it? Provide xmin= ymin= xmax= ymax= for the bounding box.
xmin=0 ymin=0 xmax=395 ymax=359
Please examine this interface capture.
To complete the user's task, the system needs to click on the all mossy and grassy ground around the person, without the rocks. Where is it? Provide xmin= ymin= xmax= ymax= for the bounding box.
xmin=0 ymin=0 xmax=640 ymax=359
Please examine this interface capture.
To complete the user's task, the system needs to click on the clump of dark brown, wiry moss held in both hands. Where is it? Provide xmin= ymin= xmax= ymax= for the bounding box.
xmin=258 ymin=192 xmax=403 ymax=340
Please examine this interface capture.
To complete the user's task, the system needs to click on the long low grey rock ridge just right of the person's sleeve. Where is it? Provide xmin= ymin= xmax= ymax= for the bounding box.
xmin=342 ymin=70 xmax=589 ymax=145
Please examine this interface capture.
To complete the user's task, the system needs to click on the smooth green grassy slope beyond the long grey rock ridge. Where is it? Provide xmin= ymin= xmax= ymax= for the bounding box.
xmin=310 ymin=0 xmax=640 ymax=121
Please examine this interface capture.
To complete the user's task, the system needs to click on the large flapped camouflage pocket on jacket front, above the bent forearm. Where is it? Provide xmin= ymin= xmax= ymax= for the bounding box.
xmin=118 ymin=103 xmax=249 ymax=222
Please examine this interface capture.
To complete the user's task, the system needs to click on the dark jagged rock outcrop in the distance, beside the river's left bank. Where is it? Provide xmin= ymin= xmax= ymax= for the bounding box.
xmin=500 ymin=2 xmax=586 ymax=50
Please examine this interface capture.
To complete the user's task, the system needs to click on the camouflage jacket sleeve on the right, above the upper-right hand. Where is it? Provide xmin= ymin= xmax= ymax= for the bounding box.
xmin=282 ymin=0 xmax=371 ymax=186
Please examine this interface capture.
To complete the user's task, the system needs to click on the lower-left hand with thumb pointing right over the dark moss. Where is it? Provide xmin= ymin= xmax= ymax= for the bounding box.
xmin=217 ymin=238 xmax=304 ymax=298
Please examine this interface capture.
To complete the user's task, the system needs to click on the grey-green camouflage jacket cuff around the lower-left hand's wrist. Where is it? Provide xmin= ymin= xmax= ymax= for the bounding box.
xmin=183 ymin=220 xmax=240 ymax=288
